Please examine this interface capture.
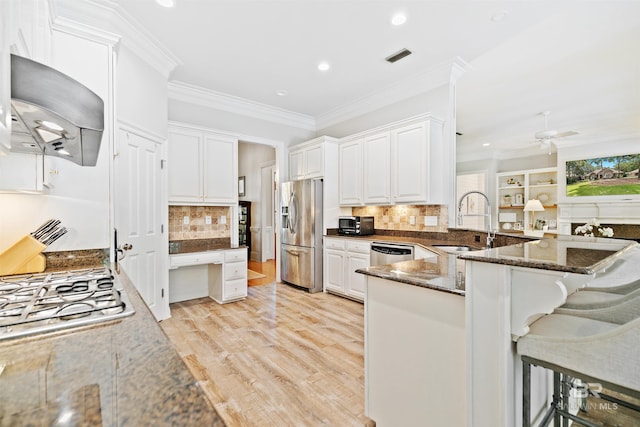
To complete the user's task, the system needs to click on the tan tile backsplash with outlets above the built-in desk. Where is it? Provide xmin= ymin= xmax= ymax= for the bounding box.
xmin=169 ymin=206 xmax=231 ymax=240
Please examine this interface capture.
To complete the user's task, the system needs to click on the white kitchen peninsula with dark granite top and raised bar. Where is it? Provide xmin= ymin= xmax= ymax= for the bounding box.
xmin=358 ymin=236 xmax=638 ymax=426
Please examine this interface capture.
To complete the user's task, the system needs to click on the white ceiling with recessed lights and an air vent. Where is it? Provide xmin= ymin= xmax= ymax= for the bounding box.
xmin=117 ymin=0 xmax=640 ymax=157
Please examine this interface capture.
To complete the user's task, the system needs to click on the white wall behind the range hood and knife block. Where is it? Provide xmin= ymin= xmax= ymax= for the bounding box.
xmin=0 ymin=31 xmax=112 ymax=251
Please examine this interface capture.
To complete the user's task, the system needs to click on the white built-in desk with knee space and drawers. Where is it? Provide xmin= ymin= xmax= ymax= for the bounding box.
xmin=169 ymin=249 xmax=247 ymax=304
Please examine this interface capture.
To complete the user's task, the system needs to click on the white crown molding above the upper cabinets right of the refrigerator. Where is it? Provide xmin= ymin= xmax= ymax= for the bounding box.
xmin=316 ymin=57 xmax=469 ymax=129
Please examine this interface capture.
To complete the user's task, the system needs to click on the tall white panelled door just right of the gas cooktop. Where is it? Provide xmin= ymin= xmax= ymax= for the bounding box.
xmin=114 ymin=129 xmax=169 ymax=320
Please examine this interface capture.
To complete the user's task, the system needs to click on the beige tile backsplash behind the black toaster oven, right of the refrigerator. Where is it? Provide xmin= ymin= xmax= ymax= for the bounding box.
xmin=352 ymin=205 xmax=449 ymax=232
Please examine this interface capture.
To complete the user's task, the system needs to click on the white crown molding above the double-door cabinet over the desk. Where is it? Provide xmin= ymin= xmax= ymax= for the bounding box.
xmin=168 ymin=81 xmax=316 ymax=131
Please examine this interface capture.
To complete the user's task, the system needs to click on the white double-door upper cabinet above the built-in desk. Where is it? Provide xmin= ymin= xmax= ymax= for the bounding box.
xmin=168 ymin=124 xmax=238 ymax=205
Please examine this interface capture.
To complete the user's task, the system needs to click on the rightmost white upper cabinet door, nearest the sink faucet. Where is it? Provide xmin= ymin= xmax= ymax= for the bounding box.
xmin=391 ymin=122 xmax=428 ymax=203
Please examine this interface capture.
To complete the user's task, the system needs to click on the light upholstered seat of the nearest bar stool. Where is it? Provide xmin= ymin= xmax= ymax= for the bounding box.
xmin=517 ymin=314 xmax=640 ymax=390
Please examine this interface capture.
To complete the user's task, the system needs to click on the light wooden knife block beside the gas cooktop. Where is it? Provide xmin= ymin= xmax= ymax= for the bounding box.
xmin=0 ymin=235 xmax=47 ymax=276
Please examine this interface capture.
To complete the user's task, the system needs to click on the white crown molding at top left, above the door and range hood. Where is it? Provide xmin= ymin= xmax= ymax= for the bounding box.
xmin=49 ymin=0 xmax=182 ymax=79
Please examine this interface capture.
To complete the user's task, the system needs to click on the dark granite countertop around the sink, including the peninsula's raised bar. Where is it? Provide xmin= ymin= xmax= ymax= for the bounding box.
xmin=338 ymin=229 xmax=638 ymax=295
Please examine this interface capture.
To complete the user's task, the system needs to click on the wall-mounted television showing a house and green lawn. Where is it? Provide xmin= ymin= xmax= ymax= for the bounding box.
xmin=565 ymin=154 xmax=640 ymax=197
